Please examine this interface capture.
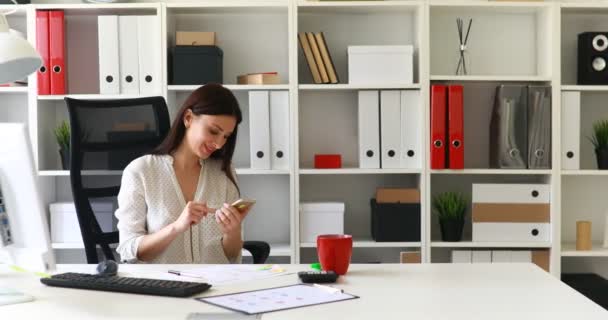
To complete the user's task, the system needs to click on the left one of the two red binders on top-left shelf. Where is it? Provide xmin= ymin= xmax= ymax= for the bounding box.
xmin=36 ymin=10 xmax=51 ymax=95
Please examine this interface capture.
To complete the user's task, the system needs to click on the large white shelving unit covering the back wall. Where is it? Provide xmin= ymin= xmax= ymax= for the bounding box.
xmin=0 ymin=0 xmax=608 ymax=276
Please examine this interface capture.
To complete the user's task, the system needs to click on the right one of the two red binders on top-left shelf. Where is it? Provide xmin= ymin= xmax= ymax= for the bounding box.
xmin=48 ymin=10 xmax=66 ymax=94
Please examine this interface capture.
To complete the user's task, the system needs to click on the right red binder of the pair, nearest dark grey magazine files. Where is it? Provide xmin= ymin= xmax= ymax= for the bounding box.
xmin=448 ymin=85 xmax=464 ymax=169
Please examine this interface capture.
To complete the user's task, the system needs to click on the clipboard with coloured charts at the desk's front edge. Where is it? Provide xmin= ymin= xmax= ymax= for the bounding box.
xmin=195 ymin=284 xmax=359 ymax=315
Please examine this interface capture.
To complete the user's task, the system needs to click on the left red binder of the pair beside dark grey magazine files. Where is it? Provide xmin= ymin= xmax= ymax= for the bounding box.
xmin=431 ymin=85 xmax=447 ymax=169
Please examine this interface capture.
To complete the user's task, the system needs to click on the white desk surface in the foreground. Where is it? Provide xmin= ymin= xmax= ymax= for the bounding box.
xmin=0 ymin=264 xmax=608 ymax=320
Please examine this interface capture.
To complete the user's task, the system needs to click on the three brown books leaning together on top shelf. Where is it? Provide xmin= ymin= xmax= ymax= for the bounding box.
xmin=298 ymin=32 xmax=340 ymax=83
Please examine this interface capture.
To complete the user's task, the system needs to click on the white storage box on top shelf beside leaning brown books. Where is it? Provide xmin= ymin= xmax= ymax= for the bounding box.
xmin=348 ymin=45 xmax=414 ymax=85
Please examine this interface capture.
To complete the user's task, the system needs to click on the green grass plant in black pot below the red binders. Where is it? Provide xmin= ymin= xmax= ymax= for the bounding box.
xmin=433 ymin=192 xmax=467 ymax=241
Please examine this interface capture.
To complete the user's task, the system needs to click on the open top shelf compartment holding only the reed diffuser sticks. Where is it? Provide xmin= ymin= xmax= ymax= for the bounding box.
xmin=430 ymin=2 xmax=553 ymax=81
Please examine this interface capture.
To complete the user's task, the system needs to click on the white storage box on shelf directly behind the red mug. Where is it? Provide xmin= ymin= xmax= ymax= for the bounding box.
xmin=300 ymin=202 xmax=344 ymax=243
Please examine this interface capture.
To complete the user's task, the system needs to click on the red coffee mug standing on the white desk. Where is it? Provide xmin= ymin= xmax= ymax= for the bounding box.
xmin=317 ymin=234 xmax=353 ymax=275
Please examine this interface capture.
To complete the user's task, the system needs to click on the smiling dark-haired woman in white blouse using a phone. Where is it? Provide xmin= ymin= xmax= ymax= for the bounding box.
xmin=116 ymin=84 xmax=248 ymax=264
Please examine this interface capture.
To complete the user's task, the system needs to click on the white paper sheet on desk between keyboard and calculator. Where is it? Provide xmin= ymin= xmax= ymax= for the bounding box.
xmin=179 ymin=264 xmax=289 ymax=286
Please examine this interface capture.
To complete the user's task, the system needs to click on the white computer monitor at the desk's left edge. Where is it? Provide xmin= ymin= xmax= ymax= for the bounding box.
xmin=0 ymin=123 xmax=55 ymax=271
